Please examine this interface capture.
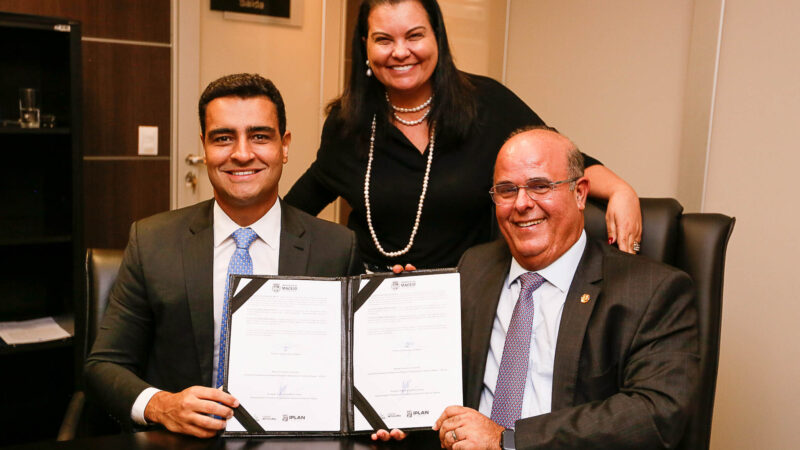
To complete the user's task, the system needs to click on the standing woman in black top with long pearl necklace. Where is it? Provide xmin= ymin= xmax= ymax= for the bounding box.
xmin=285 ymin=0 xmax=641 ymax=271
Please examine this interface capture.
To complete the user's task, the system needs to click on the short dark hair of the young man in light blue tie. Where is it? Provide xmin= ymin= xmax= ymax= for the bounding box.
xmin=197 ymin=73 xmax=286 ymax=137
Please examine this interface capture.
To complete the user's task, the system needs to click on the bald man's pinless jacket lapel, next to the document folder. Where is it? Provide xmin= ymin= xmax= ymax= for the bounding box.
xmin=461 ymin=241 xmax=511 ymax=408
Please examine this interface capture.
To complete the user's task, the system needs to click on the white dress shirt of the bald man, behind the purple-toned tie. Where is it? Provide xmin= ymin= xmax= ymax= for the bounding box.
xmin=478 ymin=231 xmax=586 ymax=418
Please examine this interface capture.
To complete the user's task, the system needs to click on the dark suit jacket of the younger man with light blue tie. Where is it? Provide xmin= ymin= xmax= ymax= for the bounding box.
xmin=84 ymin=200 xmax=362 ymax=425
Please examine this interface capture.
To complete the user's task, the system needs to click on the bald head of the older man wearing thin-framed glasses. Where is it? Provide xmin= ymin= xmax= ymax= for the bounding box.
xmin=494 ymin=128 xmax=589 ymax=270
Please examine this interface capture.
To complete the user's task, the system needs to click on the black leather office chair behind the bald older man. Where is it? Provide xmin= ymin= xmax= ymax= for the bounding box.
xmin=585 ymin=198 xmax=735 ymax=450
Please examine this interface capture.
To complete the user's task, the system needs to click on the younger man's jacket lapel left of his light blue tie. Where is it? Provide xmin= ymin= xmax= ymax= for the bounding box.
xmin=183 ymin=201 xmax=214 ymax=386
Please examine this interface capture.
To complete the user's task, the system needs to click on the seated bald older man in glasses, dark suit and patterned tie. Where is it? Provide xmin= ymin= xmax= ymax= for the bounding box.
xmin=432 ymin=128 xmax=698 ymax=449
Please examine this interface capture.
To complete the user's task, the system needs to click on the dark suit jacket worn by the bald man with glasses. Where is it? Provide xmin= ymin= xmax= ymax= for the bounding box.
xmin=459 ymin=239 xmax=699 ymax=449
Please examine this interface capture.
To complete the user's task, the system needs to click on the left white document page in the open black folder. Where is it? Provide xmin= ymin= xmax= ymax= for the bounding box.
xmin=227 ymin=279 xmax=342 ymax=431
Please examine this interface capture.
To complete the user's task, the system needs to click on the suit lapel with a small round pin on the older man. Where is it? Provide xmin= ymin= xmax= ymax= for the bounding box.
xmin=551 ymin=239 xmax=603 ymax=411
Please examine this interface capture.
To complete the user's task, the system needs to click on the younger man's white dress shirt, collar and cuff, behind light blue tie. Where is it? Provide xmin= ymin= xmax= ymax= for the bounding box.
xmin=131 ymin=201 xmax=281 ymax=425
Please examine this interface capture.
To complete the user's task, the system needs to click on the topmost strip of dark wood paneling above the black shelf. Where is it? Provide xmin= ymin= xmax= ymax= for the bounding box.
xmin=0 ymin=0 xmax=170 ymax=43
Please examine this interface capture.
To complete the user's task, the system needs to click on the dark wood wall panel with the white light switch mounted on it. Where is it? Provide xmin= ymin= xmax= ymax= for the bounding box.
xmin=83 ymin=42 xmax=171 ymax=156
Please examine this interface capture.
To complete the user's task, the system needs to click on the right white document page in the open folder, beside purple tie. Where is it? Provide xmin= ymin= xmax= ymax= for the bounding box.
xmin=353 ymin=273 xmax=463 ymax=430
